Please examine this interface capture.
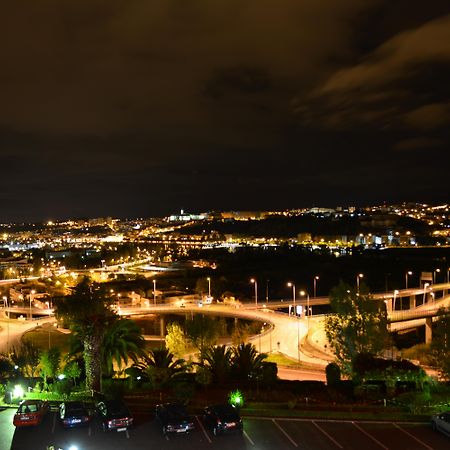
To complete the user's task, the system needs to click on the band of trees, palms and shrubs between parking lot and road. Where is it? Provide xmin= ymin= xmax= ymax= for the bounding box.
xmin=0 ymin=279 xmax=450 ymax=418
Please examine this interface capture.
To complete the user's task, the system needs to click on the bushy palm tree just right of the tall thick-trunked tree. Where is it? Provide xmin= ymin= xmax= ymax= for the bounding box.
xmin=102 ymin=318 xmax=145 ymax=375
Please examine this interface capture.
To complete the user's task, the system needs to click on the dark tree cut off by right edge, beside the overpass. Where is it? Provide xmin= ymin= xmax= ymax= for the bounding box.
xmin=430 ymin=308 xmax=450 ymax=379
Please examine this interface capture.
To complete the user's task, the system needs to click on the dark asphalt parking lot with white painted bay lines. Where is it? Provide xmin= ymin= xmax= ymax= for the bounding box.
xmin=0 ymin=410 xmax=450 ymax=450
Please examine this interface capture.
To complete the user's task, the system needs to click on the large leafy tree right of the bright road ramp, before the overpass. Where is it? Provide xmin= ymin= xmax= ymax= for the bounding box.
xmin=325 ymin=282 xmax=389 ymax=374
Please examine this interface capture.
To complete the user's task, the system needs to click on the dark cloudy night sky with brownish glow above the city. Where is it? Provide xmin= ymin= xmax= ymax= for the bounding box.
xmin=0 ymin=0 xmax=450 ymax=222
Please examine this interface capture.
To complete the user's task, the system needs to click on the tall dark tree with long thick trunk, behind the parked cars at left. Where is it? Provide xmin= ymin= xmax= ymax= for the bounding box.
xmin=54 ymin=278 xmax=116 ymax=391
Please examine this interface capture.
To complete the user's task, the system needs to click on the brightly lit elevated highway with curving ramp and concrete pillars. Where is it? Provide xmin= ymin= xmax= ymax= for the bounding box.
xmin=2 ymin=283 xmax=450 ymax=367
